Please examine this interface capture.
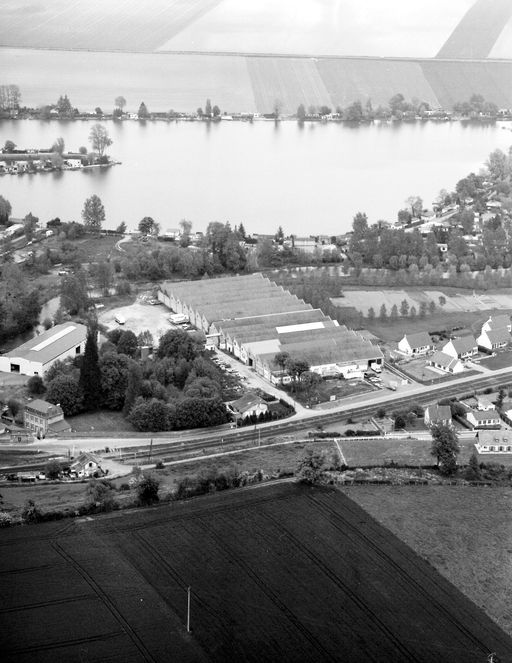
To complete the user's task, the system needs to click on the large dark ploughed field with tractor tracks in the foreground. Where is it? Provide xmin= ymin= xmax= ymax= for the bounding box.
xmin=0 ymin=484 xmax=512 ymax=663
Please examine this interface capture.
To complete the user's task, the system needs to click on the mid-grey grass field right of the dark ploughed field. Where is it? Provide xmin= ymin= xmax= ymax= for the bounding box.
xmin=342 ymin=486 xmax=512 ymax=634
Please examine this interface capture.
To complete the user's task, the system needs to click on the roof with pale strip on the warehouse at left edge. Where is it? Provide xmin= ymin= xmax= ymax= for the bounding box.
xmin=7 ymin=322 xmax=87 ymax=364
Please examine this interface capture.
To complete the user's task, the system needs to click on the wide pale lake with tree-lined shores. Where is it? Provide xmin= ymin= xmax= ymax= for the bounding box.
xmin=0 ymin=120 xmax=512 ymax=235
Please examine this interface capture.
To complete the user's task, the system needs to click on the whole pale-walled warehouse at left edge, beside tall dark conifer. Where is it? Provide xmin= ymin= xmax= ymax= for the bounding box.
xmin=0 ymin=322 xmax=87 ymax=376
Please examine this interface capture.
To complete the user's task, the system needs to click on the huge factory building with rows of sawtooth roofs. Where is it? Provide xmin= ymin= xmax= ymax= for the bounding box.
xmin=158 ymin=274 xmax=383 ymax=383
